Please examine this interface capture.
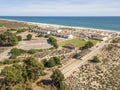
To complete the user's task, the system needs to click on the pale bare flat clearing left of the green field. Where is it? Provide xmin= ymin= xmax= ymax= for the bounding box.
xmin=17 ymin=39 xmax=52 ymax=50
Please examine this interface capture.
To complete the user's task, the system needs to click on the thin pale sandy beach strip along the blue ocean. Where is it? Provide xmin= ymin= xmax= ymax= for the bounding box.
xmin=0 ymin=18 xmax=120 ymax=33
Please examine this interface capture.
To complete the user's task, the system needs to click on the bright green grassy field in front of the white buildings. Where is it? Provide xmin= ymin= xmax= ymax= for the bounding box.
xmin=58 ymin=38 xmax=98 ymax=48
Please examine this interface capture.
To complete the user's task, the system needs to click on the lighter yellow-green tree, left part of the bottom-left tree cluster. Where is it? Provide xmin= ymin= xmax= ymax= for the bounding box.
xmin=1 ymin=64 xmax=24 ymax=88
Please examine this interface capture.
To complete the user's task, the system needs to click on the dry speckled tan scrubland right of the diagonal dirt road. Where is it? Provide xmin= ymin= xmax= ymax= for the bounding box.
xmin=66 ymin=37 xmax=120 ymax=90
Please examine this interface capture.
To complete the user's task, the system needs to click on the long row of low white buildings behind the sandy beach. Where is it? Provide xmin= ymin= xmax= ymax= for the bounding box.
xmin=32 ymin=29 xmax=108 ymax=41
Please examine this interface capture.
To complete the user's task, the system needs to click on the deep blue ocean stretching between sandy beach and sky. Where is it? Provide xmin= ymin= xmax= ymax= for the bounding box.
xmin=0 ymin=16 xmax=120 ymax=31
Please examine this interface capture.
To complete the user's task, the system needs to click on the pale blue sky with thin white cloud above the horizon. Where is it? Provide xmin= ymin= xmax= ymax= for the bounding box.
xmin=0 ymin=0 xmax=120 ymax=16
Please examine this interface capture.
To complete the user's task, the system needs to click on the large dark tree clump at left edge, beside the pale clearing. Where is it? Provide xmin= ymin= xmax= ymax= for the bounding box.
xmin=0 ymin=32 xmax=21 ymax=46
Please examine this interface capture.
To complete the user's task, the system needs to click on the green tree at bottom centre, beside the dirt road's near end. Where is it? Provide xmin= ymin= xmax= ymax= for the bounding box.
xmin=51 ymin=69 xmax=66 ymax=90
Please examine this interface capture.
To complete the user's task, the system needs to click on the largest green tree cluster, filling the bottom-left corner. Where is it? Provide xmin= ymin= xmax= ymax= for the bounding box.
xmin=0 ymin=57 xmax=44 ymax=90
